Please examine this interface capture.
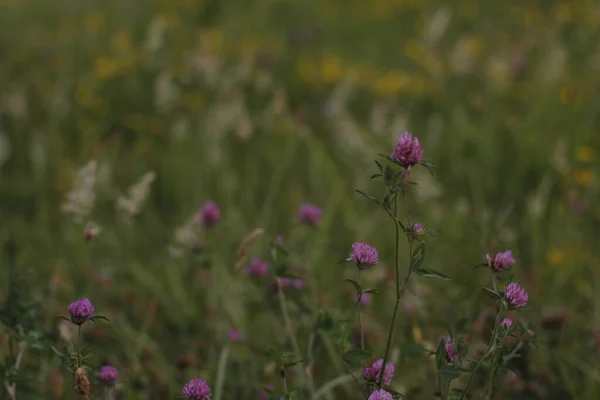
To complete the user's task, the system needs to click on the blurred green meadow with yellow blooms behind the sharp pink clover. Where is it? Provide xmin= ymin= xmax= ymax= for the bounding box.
xmin=0 ymin=0 xmax=600 ymax=400
